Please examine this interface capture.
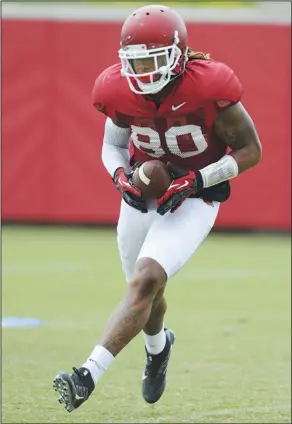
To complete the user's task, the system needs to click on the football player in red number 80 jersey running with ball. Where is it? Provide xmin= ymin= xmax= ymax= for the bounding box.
xmin=54 ymin=5 xmax=262 ymax=412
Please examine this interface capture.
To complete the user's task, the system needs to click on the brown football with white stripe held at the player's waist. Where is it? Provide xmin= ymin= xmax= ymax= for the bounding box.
xmin=132 ymin=160 xmax=172 ymax=200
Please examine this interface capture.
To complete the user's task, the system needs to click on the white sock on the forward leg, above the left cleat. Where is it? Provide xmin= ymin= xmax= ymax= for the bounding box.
xmin=82 ymin=345 xmax=115 ymax=384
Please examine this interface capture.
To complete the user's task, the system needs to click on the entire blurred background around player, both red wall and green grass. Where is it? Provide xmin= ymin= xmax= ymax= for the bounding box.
xmin=2 ymin=1 xmax=291 ymax=423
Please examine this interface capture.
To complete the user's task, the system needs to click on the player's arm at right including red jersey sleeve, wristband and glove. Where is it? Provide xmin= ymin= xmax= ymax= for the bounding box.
xmin=157 ymin=63 xmax=262 ymax=215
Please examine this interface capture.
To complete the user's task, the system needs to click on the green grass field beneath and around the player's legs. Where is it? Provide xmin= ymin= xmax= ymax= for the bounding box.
xmin=2 ymin=227 xmax=291 ymax=423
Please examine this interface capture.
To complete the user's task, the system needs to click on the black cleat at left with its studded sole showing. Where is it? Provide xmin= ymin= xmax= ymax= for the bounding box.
xmin=53 ymin=368 xmax=94 ymax=412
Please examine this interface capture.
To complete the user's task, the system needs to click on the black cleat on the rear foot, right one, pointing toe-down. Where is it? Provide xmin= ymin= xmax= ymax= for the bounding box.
xmin=142 ymin=329 xmax=175 ymax=403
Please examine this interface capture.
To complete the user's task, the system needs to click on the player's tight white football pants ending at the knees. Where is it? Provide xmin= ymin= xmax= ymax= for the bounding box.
xmin=117 ymin=198 xmax=220 ymax=282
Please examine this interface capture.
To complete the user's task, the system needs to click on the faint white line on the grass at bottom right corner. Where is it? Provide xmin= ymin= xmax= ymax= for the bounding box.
xmin=191 ymin=403 xmax=291 ymax=423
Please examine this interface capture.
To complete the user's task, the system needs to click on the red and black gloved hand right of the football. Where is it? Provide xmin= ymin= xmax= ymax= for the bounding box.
xmin=157 ymin=162 xmax=197 ymax=215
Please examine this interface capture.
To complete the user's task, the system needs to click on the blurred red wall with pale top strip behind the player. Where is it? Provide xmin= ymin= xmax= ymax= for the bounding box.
xmin=2 ymin=2 xmax=291 ymax=230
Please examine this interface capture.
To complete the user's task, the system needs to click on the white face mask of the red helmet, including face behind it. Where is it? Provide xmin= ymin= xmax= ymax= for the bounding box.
xmin=119 ymin=34 xmax=182 ymax=94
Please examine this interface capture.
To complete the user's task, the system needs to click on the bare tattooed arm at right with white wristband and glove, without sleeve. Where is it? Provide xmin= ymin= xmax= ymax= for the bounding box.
xmin=157 ymin=102 xmax=262 ymax=215
